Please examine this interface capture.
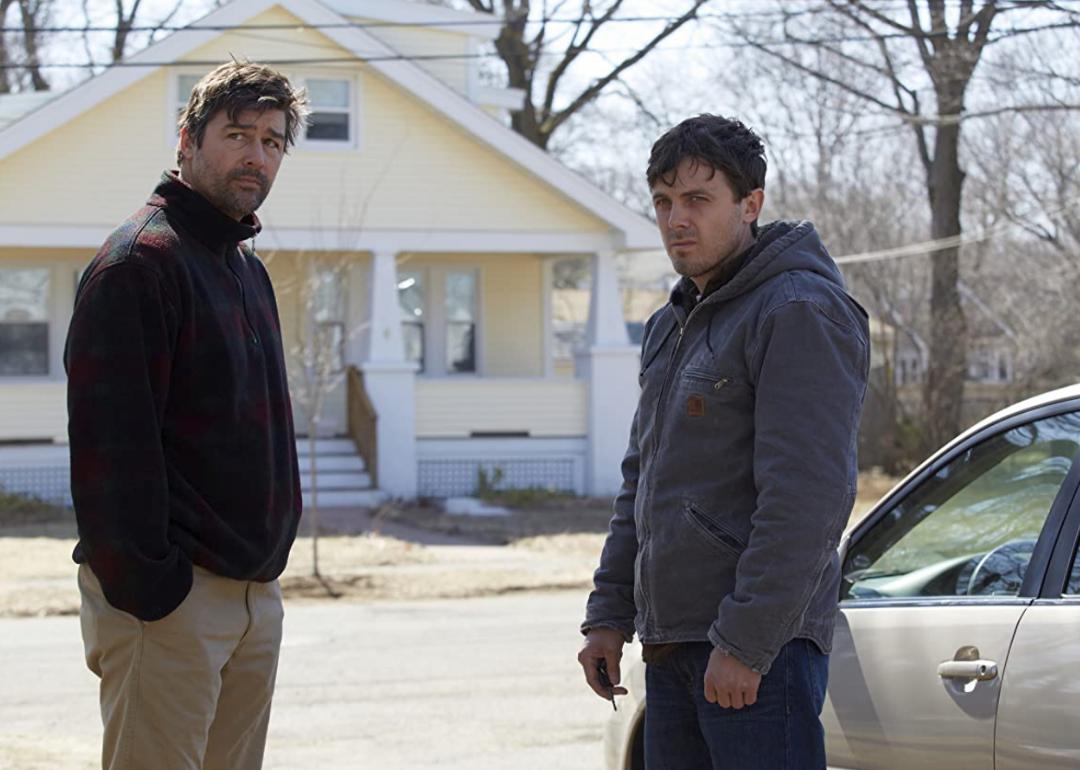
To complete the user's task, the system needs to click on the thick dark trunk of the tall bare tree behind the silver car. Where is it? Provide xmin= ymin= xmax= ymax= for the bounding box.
xmin=922 ymin=95 xmax=968 ymax=454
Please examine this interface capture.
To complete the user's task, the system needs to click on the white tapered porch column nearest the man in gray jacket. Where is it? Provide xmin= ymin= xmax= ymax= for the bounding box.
xmin=575 ymin=252 xmax=638 ymax=495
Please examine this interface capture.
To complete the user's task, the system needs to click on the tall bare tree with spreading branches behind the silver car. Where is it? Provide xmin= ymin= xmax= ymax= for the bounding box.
xmin=734 ymin=0 xmax=1076 ymax=449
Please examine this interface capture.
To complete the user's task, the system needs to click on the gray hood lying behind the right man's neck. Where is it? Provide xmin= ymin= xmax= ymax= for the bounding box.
xmin=672 ymin=219 xmax=845 ymax=303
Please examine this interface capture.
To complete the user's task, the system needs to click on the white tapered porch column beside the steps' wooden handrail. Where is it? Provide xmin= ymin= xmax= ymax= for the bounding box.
xmin=360 ymin=252 xmax=417 ymax=500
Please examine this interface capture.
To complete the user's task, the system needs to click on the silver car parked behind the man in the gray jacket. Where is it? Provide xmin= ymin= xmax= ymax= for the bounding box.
xmin=606 ymin=386 xmax=1080 ymax=770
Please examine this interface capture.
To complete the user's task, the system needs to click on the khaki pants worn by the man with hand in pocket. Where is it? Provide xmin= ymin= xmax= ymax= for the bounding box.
xmin=79 ymin=565 xmax=284 ymax=770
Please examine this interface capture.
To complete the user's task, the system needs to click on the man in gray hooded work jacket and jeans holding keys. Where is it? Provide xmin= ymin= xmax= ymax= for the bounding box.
xmin=578 ymin=114 xmax=869 ymax=770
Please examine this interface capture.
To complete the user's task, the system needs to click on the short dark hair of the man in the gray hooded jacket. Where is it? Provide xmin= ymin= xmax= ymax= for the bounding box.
xmin=645 ymin=114 xmax=767 ymax=211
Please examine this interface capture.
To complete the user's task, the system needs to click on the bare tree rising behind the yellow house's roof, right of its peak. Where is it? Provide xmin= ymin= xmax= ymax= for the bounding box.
xmin=446 ymin=0 xmax=708 ymax=149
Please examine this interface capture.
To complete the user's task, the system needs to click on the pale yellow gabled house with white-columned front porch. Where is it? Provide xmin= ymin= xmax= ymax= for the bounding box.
xmin=0 ymin=0 xmax=659 ymax=498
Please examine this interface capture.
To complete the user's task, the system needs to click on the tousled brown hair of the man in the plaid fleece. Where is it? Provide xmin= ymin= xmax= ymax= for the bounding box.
xmin=176 ymin=60 xmax=311 ymax=163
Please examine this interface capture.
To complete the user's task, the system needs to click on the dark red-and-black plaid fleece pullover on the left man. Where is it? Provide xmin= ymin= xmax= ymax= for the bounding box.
xmin=64 ymin=172 xmax=301 ymax=621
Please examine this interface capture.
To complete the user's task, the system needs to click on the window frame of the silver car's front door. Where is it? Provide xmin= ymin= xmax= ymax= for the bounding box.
xmin=840 ymin=398 xmax=1080 ymax=610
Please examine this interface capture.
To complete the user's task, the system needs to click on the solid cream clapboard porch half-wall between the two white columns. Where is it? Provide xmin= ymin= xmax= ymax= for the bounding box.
xmin=416 ymin=377 xmax=589 ymax=438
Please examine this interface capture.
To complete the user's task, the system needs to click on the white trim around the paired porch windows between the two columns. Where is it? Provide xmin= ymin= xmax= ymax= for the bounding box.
xmin=402 ymin=262 xmax=487 ymax=379
